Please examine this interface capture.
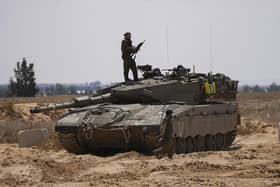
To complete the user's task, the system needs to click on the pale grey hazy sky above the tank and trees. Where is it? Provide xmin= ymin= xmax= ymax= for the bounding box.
xmin=0 ymin=0 xmax=280 ymax=84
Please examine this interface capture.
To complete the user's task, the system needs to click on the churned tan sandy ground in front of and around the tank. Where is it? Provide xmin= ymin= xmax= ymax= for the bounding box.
xmin=0 ymin=95 xmax=280 ymax=186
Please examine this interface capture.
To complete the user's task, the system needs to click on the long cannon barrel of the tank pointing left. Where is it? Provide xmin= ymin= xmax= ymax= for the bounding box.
xmin=30 ymin=93 xmax=112 ymax=113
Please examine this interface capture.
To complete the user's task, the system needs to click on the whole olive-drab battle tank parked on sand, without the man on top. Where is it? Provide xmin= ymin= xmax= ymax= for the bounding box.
xmin=31 ymin=65 xmax=240 ymax=154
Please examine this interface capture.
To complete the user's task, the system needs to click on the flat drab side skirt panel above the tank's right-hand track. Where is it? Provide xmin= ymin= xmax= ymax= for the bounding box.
xmin=172 ymin=104 xmax=240 ymax=138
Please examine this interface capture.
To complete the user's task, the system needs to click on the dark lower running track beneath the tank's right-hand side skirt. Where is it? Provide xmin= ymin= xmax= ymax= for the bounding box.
xmin=173 ymin=131 xmax=236 ymax=154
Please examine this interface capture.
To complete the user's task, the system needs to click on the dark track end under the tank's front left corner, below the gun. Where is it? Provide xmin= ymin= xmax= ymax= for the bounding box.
xmin=58 ymin=132 xmax=88 ymax=154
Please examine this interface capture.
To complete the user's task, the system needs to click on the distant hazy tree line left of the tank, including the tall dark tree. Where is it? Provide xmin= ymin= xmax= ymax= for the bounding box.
xmin=0 ymin=58 xmax=103 ymax=97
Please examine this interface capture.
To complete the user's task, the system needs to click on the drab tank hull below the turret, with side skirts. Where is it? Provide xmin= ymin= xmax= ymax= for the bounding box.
xmin=56 ymin=103 xmax=240 ymax=153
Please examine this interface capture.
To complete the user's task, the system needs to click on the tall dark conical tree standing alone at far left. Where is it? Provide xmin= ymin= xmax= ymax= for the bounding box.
xmin=9 ymin=58 xmax=38 ymax=97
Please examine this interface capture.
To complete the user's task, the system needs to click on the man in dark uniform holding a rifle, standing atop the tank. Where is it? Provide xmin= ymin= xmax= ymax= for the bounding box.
xmin=121 ymin=32 xmax=144 ymax=82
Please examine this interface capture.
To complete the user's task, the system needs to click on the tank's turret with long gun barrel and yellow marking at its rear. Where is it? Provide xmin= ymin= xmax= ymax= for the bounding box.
xmin=31 ymin=65 xmax=238 ymax=113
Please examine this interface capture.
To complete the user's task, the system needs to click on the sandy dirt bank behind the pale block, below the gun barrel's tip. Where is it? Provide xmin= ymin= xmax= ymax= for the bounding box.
xmin=0 ymin=103 xmax=65 ymax=144
